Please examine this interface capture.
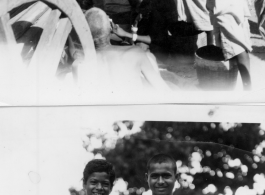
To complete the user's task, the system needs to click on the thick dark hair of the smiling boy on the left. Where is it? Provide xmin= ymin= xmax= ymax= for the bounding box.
xmin=83 ymin=159 xmax=115 ymax=187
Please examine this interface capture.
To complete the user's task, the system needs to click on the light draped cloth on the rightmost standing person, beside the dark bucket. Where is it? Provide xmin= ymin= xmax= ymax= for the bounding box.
xmin=207 ymin=0 xmax=252 ymax=60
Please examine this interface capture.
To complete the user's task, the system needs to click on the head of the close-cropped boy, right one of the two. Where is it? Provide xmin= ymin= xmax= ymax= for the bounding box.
xmin=146 ymin=154 xmax=177 ymax=195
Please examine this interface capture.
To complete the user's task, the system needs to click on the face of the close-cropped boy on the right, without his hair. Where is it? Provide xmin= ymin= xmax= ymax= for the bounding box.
xmin=146 ymin=162 xmax=176 ymax=195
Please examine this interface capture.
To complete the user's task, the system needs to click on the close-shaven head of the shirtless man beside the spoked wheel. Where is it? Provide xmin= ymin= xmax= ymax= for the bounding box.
xmin=85 ymin=7 xmax=111 ymax=46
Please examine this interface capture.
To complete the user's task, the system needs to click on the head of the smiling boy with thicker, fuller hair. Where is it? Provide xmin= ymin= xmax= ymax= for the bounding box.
xmin=83 ymin=159 xmax=115 ymax=195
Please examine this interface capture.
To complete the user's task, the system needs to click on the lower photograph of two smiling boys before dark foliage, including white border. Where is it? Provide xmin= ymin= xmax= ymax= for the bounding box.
xmin=0 ymin=106 xmax=265 ymax=195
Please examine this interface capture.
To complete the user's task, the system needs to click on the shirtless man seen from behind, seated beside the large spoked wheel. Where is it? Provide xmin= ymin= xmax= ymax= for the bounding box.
xmin=78 ymin=8 xmax=169 ymax=92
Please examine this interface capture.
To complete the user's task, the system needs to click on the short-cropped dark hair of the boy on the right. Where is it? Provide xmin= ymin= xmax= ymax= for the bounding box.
xmin=147 ymin=153 xmax=177 ymax=174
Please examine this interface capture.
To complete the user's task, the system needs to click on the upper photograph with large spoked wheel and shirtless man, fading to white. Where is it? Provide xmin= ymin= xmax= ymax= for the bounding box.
xmin=0 ymin=0 xmax=265 ymax=106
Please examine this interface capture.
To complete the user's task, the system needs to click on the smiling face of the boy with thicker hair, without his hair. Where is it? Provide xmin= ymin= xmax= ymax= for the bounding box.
xmin=83 ymin=172 xmax=111 ymax=195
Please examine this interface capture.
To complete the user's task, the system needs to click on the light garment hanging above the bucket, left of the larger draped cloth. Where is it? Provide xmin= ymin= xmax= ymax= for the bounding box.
xmin=175 ymin=0 xmax=213 ymax=31
